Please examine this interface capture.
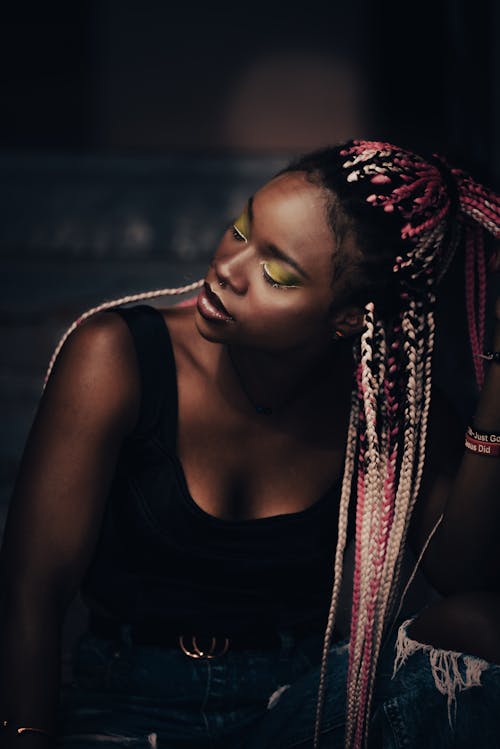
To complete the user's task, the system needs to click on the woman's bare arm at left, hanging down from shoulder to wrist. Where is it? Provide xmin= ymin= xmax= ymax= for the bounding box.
xmin=0 ymin=313 xmax=140 ymax=749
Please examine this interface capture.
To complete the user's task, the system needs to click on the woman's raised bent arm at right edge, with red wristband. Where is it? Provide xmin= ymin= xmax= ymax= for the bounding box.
xmin=410 ymin=300 xmax=500 ymax=595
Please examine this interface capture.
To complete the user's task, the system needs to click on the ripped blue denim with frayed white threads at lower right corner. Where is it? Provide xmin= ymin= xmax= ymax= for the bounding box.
xmin=370 ymin=619 xmax=500 ymax=749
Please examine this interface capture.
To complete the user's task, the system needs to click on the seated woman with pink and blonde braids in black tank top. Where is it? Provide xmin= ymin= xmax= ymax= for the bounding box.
xmin=0 ymin=141 xmax=500 ymax=749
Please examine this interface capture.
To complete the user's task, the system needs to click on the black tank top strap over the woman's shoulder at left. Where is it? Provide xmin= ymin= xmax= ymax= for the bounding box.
xmin=109 ymin=304 xmax=178 ymax=449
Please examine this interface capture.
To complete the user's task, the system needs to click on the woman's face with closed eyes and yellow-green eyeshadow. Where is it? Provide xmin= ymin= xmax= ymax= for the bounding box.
xmin=196 ymin=172 xmax=348 ymax=351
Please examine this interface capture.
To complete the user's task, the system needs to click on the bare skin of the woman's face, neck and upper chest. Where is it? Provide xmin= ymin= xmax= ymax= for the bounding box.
xmin=165 ymin=174 xmax=361 ymax=519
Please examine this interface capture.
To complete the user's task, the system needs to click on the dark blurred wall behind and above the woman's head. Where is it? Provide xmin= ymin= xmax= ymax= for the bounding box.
xmin=0 ymin=0 xmax=500 ymax=174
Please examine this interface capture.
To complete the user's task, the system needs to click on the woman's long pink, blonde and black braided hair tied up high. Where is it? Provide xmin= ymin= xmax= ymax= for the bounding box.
xmin=284 ymin=140 xmax=500 ymax=749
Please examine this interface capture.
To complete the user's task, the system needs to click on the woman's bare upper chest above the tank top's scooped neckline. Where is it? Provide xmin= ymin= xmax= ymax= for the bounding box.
xmin=178 ymin=382 xmax=348 ymax=520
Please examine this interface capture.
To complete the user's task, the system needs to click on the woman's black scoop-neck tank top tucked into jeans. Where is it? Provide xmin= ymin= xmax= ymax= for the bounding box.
xmin=82 ymin=305 xmax=352 ymax=634
